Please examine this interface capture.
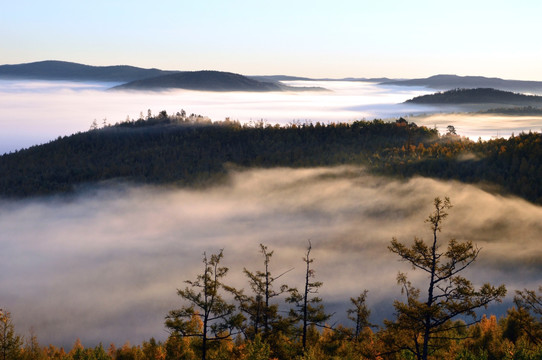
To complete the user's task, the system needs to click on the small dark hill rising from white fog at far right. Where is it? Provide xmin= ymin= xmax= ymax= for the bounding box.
xmin=405 ymin=88 xmax=542 ymax=106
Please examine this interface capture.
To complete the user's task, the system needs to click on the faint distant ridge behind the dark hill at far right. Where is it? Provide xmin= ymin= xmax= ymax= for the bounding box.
xmin=381 ymin=75 xmax=542 ymax=93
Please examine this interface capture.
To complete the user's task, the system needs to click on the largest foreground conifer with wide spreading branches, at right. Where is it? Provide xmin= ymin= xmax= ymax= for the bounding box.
xmin=387 ymin=197 xmax=506 ymax=360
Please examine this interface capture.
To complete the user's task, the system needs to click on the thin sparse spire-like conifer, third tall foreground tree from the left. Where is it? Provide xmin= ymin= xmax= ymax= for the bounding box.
xmin=286 ymin=240 xmax=331 ymax=350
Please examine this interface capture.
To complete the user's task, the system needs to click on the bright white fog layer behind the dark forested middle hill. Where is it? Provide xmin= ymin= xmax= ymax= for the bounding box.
xmin=0 ymin=80 xmax=542 ymax=154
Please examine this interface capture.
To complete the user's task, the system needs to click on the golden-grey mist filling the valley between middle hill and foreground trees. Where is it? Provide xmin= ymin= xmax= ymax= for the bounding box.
xmin=0 ymin=167 xmax=542 ymax=347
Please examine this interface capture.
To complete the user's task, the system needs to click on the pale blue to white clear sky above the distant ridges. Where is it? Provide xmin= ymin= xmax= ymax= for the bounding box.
xmin=0 ymin=0 xmax=542 ymax=80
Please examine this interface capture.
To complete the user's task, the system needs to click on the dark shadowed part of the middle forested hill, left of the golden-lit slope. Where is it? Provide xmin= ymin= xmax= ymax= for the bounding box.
xmin=0 ymin=116 xmax=436 ymax=196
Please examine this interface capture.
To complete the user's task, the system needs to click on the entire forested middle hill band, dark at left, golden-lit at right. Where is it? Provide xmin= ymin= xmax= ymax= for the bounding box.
xmin=0 ymin=111 xmax=542 ymax=203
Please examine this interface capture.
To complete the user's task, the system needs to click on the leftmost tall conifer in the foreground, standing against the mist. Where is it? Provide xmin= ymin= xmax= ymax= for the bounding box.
xmin=165 ymin=250 xmax=243 ymax=360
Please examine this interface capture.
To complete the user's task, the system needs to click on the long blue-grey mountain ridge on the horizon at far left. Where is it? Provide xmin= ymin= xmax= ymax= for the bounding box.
xmin=0 ymin=60 xmax=177 ymax=82
